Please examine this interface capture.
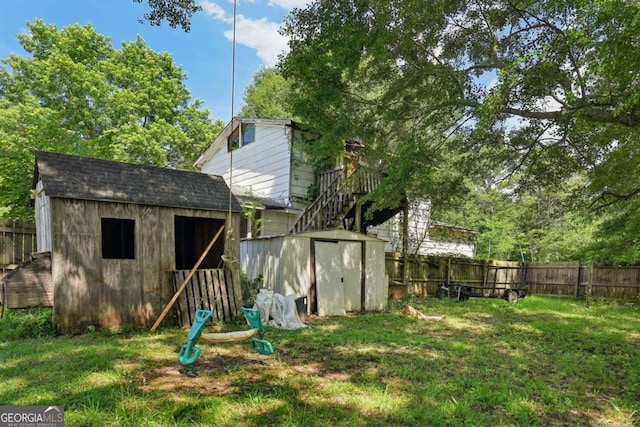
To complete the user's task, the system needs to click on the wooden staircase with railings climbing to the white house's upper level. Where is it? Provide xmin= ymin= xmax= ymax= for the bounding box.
xmin=289 ymin=169 xmax=399 ymax=233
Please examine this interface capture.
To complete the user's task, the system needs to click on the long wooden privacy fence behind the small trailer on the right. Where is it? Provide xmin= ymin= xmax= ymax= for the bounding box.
xmin=386 ymin=253 xmax=640 ymax=301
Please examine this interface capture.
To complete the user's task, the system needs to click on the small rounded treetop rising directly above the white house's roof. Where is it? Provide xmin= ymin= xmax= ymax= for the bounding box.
xmin=238 ymin=68 xmax=294 ymax=119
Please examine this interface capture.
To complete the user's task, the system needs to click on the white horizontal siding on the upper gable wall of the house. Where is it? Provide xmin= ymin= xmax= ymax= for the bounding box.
xmin=202 ymin=123 xmax=306 ymax=203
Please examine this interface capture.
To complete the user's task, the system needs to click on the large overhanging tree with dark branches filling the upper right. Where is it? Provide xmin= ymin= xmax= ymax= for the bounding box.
xmin=280 ymin=0 xmax=640 ymax=262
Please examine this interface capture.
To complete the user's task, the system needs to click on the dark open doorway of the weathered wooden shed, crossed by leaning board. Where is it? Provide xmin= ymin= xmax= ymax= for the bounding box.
xmin=174 ymin=216 xmax=224 ymax=270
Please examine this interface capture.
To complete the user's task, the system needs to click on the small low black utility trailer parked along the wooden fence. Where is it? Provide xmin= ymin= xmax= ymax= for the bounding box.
xmin=438 ymin=266 xmax=527 ymax=304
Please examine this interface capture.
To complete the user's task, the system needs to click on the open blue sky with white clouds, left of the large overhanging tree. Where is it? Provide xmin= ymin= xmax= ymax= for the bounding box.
xmin=0 ymin=0 xmax=309 ymax=122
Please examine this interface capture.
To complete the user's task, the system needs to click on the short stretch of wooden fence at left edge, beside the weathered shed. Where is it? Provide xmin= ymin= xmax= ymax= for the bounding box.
xmin=0 ymin=219 xmax=36 ymax=279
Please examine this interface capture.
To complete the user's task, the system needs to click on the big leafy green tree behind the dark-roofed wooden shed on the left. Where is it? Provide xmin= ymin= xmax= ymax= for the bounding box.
xmin=0 ymin=21 xmax=223 ymax=219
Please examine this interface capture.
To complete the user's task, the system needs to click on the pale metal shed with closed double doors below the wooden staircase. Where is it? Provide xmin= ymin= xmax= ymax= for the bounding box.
xmin=240 ymin=229 xmax=388 ymax=316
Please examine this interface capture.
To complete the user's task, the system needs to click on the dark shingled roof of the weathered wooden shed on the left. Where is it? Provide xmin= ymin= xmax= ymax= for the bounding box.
xmin=34 ymin=151 xmax=241 ymax=212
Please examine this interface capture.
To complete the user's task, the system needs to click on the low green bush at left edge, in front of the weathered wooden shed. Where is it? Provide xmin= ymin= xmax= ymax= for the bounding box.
xmin=0 ymin=307 xmax=55 ymax=341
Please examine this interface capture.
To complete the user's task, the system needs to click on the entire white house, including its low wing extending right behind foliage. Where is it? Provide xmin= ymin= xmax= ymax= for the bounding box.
xmin=195 ymin=118 xmax=475 ymax=257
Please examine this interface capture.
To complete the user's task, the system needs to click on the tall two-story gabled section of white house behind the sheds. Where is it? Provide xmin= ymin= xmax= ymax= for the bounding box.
xmin=195 ymin=118 xmax=315 ymax=237
